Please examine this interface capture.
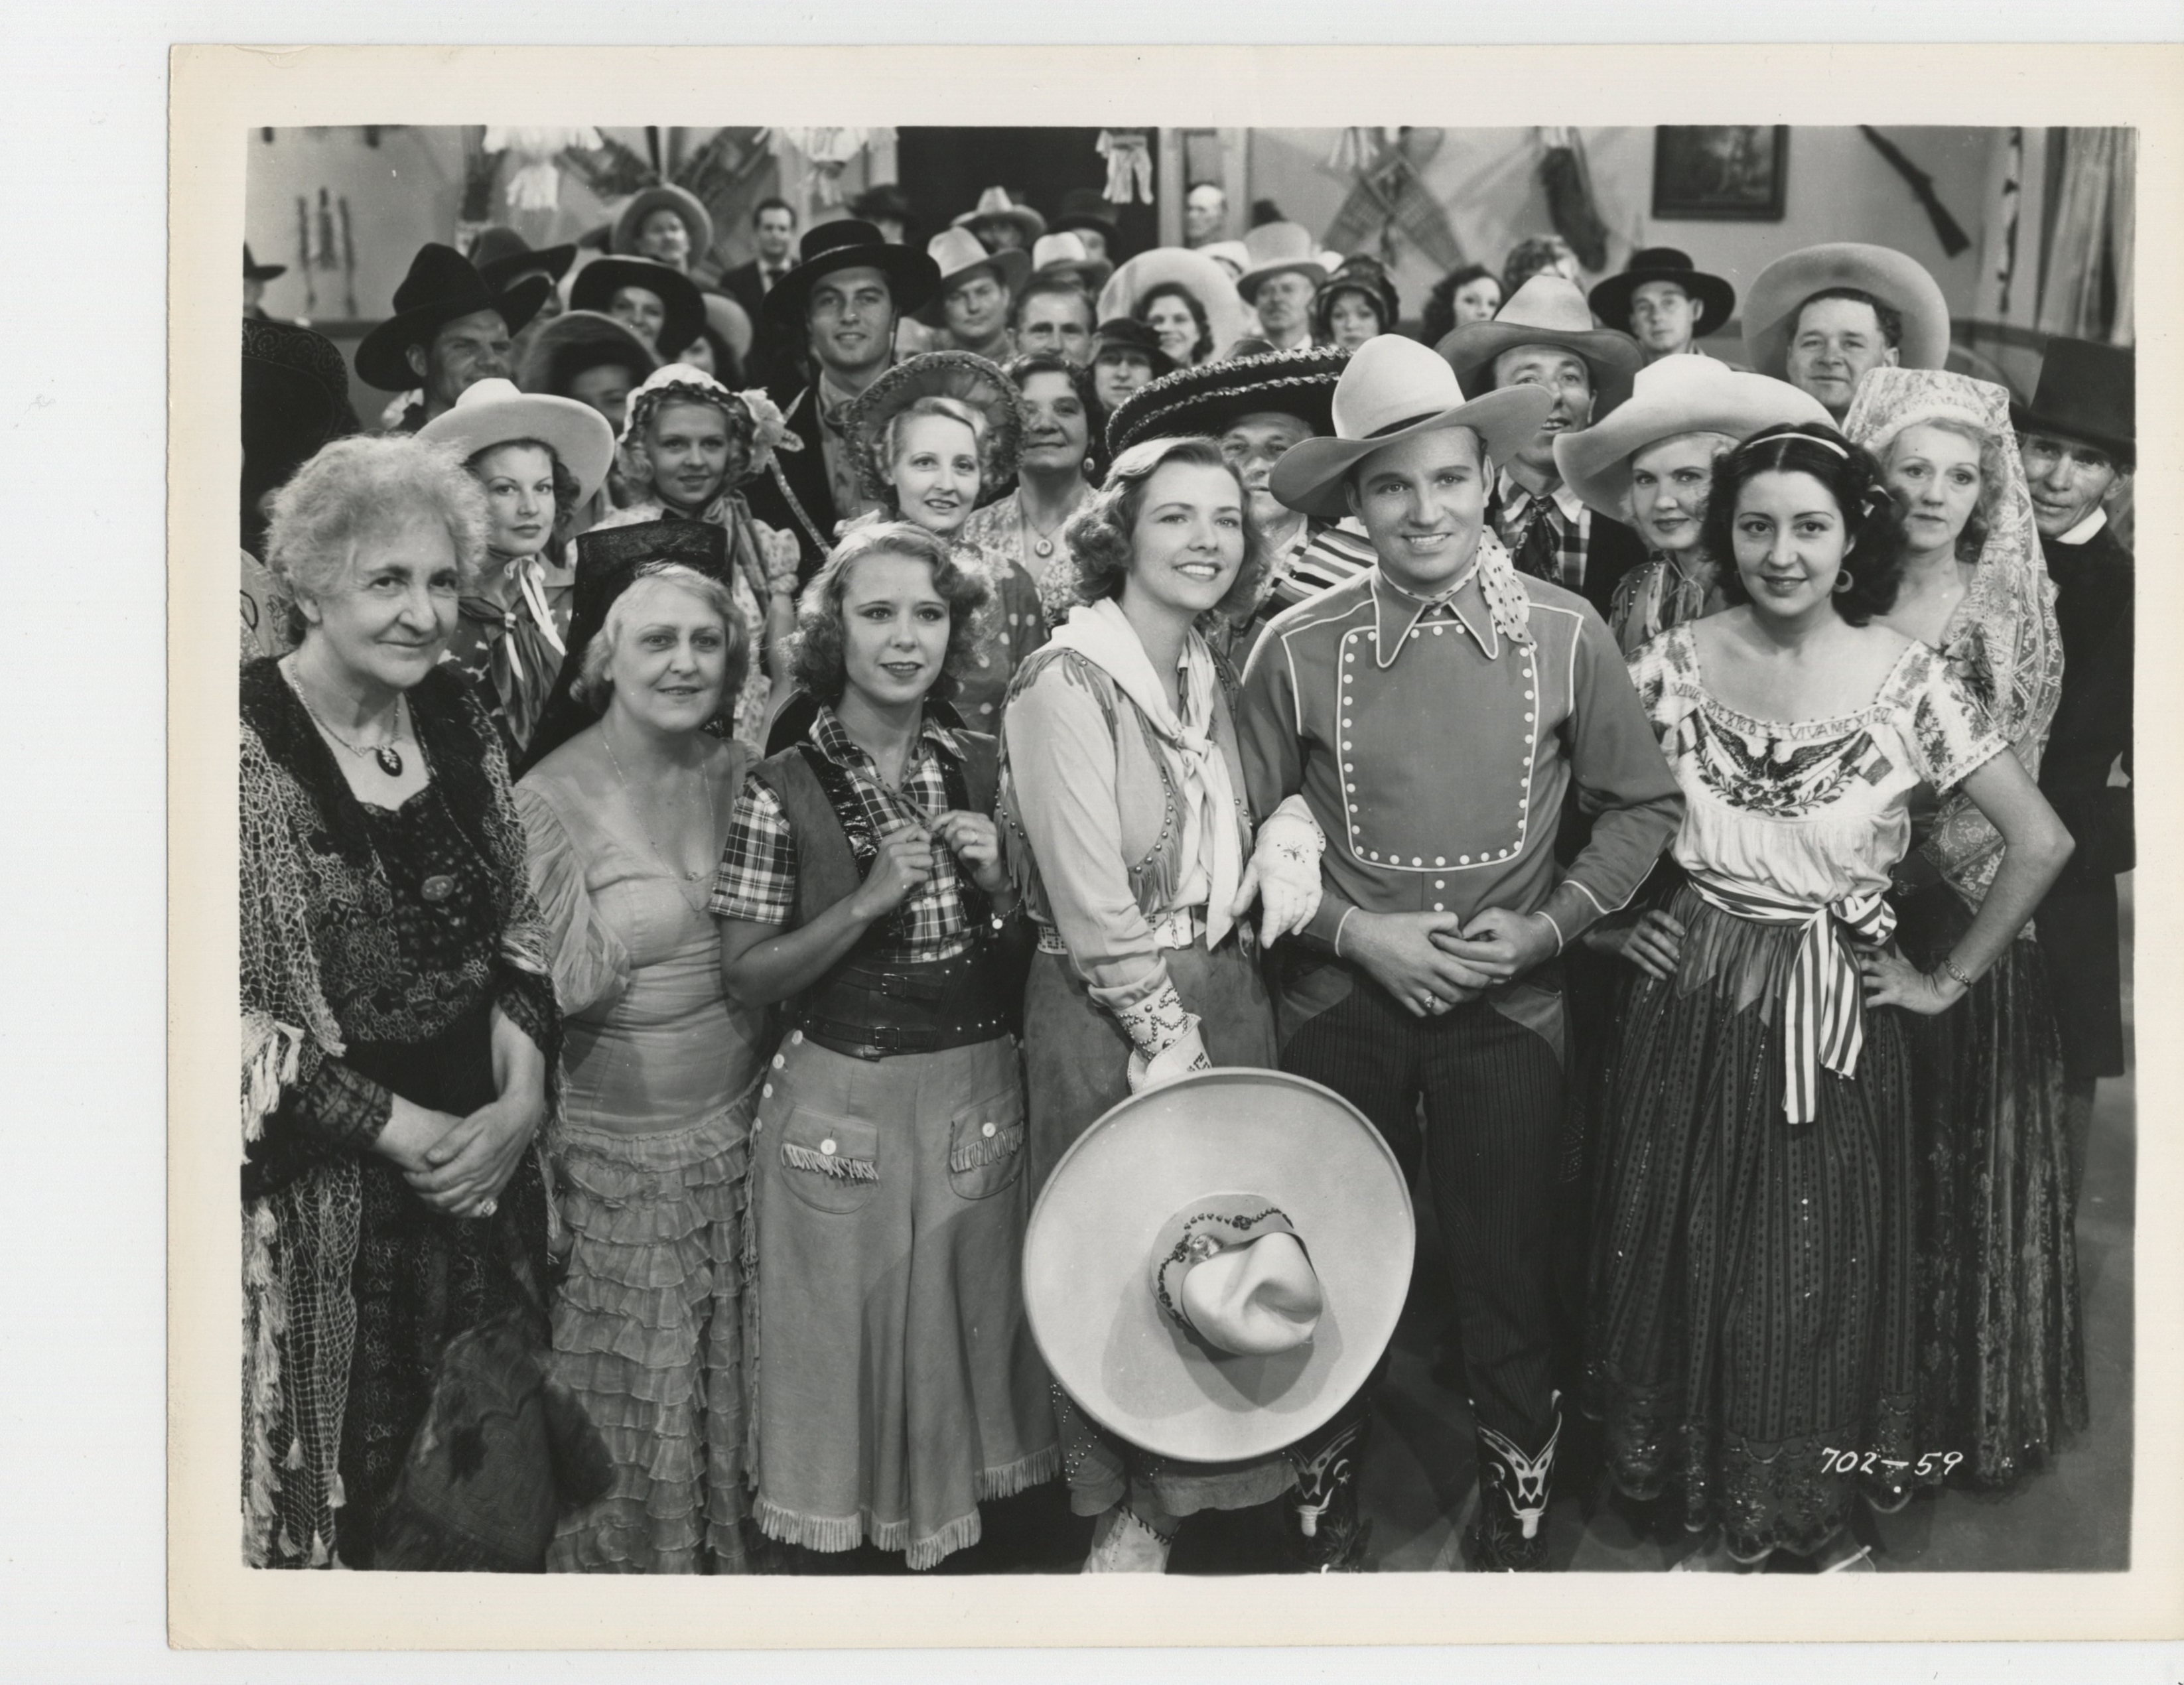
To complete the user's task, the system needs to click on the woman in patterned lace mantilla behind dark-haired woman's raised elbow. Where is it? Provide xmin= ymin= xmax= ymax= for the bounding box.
xmin=1843 ymin=369 xmax=2086 ymax=1489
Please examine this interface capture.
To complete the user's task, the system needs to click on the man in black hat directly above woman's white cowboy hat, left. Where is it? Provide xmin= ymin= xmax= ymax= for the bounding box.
xmin=356 ymin=244 xmax=553 ymax=432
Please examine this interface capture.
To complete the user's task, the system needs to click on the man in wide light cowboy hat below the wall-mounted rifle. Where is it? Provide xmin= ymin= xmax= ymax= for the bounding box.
xmin=1745 ymin=240 xmax=1948 ymax=426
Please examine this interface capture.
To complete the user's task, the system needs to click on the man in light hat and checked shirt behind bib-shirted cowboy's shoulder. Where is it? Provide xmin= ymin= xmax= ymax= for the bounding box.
xmin=1437 ymin=273 xmax=1645 ymax=616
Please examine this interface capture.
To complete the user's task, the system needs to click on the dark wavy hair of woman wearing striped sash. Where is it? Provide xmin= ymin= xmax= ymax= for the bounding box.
xmin=1701 ymin=421 xmax=1909 ymax=626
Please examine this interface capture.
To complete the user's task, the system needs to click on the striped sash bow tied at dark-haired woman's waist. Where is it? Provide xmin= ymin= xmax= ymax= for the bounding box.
xmin=1690 ymin=873 xmax=1895 ymax=1124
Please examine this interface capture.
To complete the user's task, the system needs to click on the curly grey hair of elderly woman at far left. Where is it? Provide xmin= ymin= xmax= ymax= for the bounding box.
xmin=267 ymin=435 xmax=487 ymax=644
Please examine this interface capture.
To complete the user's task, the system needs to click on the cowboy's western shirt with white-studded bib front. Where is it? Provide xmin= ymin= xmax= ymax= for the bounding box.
xmin=1236 ymin=567 xmax=1684 ymax=945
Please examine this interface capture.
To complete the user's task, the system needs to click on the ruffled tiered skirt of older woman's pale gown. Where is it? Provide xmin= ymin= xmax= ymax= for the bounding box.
xmin=546 ymin=1083 xmax=758 ymax=1574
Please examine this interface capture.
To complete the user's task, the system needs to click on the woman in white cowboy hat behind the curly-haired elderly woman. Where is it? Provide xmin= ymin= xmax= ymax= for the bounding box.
xmin=417 ymin=379 xmax=614 ymax=762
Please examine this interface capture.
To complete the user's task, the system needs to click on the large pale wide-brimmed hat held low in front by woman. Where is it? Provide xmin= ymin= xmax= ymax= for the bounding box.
xmin=1024 ymin=1069 xmax=1415 ymax=1462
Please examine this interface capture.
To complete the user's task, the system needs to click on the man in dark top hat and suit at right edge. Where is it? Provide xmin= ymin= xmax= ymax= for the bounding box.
xmin=2012 ymin=338 xmax=2138 ymax=1205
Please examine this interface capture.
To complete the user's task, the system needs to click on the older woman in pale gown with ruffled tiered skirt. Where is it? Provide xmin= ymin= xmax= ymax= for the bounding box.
xmin=515 ymin=521 xmax=764 ymax=1574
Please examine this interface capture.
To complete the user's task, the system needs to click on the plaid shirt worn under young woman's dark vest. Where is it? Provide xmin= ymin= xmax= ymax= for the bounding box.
xmin=710 ymin=707 xmax=972 ymax=965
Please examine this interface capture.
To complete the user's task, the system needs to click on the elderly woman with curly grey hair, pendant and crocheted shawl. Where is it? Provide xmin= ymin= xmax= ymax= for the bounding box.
xmin=240 ymin=438 xmax=561 ymax=1567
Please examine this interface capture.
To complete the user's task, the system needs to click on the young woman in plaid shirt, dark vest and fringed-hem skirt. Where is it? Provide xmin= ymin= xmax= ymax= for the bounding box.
xmin=712 ymin=521 xmax=1059 ymax=1570
